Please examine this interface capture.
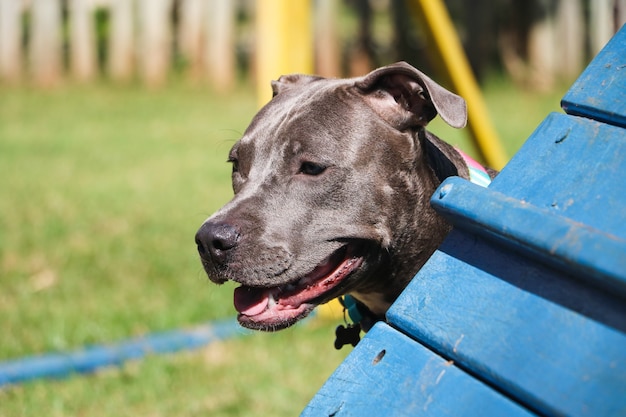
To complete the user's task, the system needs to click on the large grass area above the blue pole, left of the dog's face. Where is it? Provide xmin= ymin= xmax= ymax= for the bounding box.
xmin=0 ymin=83 xmax=254 ymax=357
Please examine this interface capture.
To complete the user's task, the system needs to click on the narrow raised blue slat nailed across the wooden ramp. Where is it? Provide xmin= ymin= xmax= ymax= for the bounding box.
xmin=431 ymin=177 xmax=626 ymax=300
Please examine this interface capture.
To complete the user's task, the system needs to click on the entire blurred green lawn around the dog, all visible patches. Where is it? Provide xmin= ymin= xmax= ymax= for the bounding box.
xmin=0 ymin=78 xmax=565 ymax=416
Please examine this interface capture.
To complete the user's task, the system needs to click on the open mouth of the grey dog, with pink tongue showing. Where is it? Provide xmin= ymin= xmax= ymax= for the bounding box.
xmin=234 ymin=245 xmax=364 ymax=331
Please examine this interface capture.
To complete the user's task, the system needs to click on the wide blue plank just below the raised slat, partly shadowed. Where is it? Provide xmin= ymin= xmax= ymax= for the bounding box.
xmin=387 ymin=239 xmax=626 ymax=416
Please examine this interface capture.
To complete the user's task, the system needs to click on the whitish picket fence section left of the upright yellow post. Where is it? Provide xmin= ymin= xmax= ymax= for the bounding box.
xmin=0 ymin=0 xmax=238 ymax=89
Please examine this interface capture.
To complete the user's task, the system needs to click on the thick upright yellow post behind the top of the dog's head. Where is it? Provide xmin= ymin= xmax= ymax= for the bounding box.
xmin=255 ymin=0 xmax=313 ymax=106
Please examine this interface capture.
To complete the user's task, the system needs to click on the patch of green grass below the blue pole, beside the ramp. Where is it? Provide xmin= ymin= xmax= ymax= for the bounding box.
xmin=0 ymin=322 xmax=347 ymax=417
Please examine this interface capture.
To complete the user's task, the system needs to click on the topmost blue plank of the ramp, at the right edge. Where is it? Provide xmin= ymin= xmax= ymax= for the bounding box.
xmin=561 ymin=26 xmax=626 ymax=127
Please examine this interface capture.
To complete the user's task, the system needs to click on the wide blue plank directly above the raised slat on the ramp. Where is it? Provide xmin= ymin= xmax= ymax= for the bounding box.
xmin=489 ymin=111 xmax=626 ymax=239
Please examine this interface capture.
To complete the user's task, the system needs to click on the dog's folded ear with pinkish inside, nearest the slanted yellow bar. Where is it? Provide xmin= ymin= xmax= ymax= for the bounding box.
xmin=355 ymin=62 xmax=467 ymax=129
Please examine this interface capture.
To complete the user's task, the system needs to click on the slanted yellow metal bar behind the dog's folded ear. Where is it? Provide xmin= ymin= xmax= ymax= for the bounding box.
xmin=409 ymin=0 xmax=508 ymax=169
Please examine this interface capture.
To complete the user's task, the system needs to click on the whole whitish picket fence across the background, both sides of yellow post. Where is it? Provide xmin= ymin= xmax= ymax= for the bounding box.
xmin=0 ymin=0 xmax=626 ymax=91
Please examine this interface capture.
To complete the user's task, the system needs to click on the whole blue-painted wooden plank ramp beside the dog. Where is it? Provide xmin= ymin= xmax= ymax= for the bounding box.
xmin=302 ymin=23 xmax=626 ymax=417
